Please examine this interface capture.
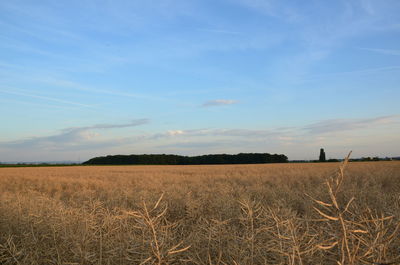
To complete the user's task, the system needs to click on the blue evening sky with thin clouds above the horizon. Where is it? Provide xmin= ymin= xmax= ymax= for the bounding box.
xmin=0 ymin=0 xmax=400 ymax=162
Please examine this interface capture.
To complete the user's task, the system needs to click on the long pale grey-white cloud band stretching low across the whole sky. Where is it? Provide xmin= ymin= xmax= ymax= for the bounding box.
xmin=0 ymin=115 xmax=400 ymax=152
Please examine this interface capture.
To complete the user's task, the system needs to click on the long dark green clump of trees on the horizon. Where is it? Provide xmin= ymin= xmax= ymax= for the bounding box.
xmin=83 ymin=153 xmax=288 ymax=165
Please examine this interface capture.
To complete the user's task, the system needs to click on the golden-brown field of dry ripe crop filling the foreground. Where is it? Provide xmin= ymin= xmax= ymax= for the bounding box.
xmin=0 ymin=162 xmax=400 ymax=265
